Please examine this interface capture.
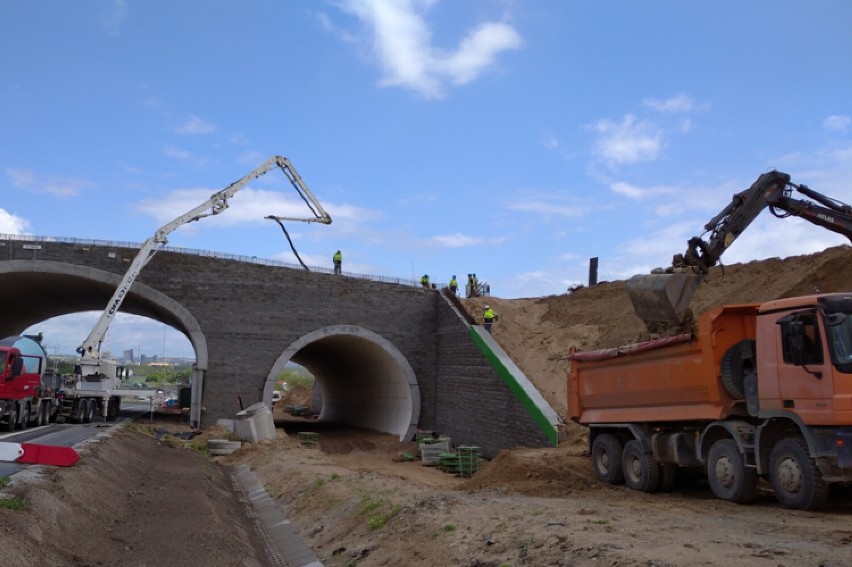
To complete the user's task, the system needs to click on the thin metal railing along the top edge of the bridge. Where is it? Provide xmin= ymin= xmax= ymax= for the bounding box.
xmin=0 ymin=234 xmax=420 ymax=287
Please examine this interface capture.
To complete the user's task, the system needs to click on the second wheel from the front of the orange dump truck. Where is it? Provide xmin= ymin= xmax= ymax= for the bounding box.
xmin=707 ymin=439 xmax=757 ymax=504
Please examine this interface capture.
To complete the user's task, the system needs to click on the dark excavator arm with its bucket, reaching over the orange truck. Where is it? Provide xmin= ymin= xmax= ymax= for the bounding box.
xmin=627 ymin=171 xmax=852 ymax=323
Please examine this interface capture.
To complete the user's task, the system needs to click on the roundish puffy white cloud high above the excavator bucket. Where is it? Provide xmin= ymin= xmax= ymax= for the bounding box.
xmin=590 ymin=114 xmax=663 ymax=167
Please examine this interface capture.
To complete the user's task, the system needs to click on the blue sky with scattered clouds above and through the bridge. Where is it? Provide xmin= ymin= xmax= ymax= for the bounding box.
xmin=0 ymin=0 xmax=852 ymax=356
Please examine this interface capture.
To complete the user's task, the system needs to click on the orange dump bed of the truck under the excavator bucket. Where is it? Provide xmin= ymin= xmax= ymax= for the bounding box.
xmin=568 ymin=304 xmax=759 ymax=425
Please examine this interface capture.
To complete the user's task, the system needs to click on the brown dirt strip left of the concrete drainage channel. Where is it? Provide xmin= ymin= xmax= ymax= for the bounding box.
xmin=0 ymin=426 xmax=269 ymax=567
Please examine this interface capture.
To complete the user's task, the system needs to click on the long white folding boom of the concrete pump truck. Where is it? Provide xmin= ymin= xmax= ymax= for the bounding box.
xmin=77 ymin=156 xmax=331 ymax=366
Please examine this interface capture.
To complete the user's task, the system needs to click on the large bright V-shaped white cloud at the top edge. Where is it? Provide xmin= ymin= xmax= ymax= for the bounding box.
xmin=332 ymin=0 xmax=522 ymax=99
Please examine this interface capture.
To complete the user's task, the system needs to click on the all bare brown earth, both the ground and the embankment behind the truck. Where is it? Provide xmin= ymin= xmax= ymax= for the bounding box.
xmin=0 ymin=247 xmax=852 ymax=567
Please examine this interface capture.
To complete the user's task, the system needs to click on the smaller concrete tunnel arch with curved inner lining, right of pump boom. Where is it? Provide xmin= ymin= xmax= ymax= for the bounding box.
xmin=263 ymin=325 xmax=420 ymax=440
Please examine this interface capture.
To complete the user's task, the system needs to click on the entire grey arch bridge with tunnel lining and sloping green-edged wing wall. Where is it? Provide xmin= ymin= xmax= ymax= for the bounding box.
xmin=0 ymin=235 xmax=561 ymax=457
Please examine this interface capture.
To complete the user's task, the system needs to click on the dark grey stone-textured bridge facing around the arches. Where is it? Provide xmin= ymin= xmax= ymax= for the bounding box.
xmin=0 ymin=239 xmax=547 ymax=456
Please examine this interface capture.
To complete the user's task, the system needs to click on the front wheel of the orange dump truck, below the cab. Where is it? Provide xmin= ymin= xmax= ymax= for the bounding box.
xmin=769 ymin=439 xmax=828 ymax=510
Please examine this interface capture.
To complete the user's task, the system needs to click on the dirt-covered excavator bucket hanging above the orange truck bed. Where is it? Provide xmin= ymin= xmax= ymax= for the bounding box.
xmin=627 ymin=274 xmax=701 ymax=323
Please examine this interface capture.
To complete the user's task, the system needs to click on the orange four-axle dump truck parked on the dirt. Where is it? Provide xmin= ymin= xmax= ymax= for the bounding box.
xmin=568 ymin=293 xmax=852 ymax=510
